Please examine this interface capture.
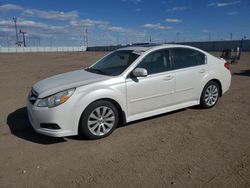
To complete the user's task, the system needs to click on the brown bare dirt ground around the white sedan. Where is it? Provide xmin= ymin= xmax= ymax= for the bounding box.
xmin=0 ymin=52 xmax=250 ymax=188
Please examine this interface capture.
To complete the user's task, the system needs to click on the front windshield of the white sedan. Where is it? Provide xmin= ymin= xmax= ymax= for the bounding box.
xmin=86 ymin=50 xmax=140 ymax=76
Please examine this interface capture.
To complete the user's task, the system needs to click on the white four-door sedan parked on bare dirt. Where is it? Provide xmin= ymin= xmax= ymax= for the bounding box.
xmin=27 ymin=45 xmax=231 ymax=139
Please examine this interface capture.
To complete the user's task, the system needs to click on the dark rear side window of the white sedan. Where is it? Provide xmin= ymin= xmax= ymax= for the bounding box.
xmin=172 ymin=48 xmax=206 ymax=69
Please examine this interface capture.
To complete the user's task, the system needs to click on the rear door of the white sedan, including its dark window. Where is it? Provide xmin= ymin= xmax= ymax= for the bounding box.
xmin=171 ymin=48 xmax=208 ymax=104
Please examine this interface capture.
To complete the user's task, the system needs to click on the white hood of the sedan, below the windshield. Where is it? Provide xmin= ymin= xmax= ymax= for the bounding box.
xmin=33 ymin=70 xmax=110 ymax=98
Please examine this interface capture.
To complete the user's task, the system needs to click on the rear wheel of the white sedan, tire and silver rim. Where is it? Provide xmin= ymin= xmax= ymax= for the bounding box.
xmin=200 ymin=81 xmax=220 ymax=109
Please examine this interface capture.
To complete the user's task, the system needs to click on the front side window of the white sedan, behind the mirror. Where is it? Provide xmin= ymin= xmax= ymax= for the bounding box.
xmin=137 ymin=50 xmax=171 ymax=74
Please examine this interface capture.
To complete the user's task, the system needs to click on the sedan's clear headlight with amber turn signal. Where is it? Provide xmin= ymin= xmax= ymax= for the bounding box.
xmin=37 ymin=89 xmax=75 ymax=108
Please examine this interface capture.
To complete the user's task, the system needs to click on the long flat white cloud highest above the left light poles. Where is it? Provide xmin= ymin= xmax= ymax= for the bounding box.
xmin=23 ymin=9 xmax=79 ymax=20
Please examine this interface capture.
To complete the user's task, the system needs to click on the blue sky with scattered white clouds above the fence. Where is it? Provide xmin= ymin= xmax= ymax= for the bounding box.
xmin=0 ymin=0 xmax=250 ymax=46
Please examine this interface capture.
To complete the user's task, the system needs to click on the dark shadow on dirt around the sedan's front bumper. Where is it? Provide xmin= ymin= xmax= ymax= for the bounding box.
xmin=7 ymin=107 xmax=66 ymax=145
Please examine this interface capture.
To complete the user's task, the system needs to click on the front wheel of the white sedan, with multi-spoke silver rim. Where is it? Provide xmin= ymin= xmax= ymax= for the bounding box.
xmin=79 ymin=100 xmax=119 ymax=140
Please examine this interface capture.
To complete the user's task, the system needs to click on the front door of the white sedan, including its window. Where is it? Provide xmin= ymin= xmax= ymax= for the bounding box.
xmin=126 ymin=50 xmax=175 ymax=116
